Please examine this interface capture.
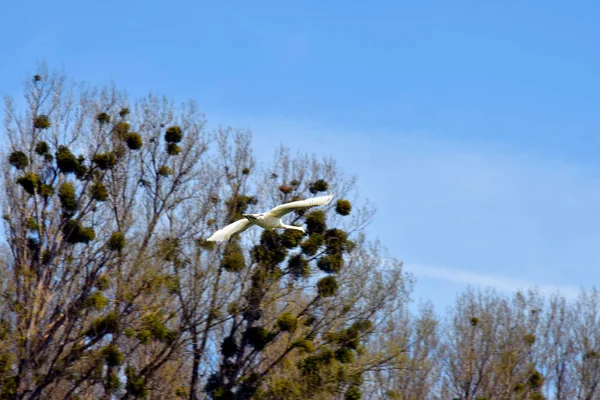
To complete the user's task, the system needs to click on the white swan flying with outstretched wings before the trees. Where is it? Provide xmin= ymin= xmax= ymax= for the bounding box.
xmin=206 ymin=194 xmax=333 ymax=242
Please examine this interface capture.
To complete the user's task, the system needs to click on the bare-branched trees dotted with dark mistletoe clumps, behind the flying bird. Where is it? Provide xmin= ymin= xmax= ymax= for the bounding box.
xmin=0 ymin=67 xmax=600 ymax=400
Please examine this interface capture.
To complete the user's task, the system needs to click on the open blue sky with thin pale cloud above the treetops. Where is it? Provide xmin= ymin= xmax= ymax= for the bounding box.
xmin=0 ymin=0 xmax=600 ymax=309
